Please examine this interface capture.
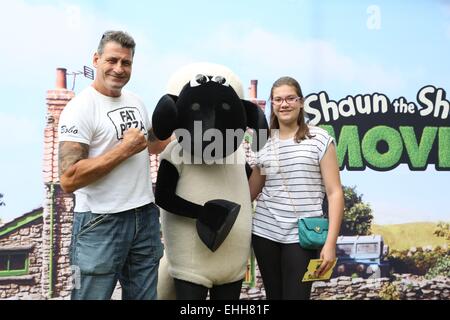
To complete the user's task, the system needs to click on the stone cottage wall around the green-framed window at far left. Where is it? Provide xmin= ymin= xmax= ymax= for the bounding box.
xmin=0 ymin=218 xmax=42 ymax=299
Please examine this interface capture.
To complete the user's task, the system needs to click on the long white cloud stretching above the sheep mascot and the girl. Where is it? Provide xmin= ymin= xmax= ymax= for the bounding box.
xmin=188 ymin=25 xmax=405 ymax=91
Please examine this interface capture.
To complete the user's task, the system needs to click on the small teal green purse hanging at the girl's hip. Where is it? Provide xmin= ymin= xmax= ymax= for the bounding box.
xmin=298 ymin=217 xmax=328 ymax=249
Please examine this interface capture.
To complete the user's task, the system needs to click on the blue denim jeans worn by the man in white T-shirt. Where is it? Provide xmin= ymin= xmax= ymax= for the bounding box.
xmin=71 ymin=203 xmax=163 ymax=300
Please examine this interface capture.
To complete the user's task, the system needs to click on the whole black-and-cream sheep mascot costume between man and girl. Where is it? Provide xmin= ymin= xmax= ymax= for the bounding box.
xmin=152 ymin=63 xmax=268 ymax=300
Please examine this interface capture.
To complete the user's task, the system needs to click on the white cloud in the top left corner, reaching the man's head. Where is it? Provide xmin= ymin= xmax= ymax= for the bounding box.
xmin=0 ymin=0 xmax=136 ymax=87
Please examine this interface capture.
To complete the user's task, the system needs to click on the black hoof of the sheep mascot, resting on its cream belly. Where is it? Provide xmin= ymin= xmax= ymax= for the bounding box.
xmin=197 ymin=199 xmax=241 ymax=252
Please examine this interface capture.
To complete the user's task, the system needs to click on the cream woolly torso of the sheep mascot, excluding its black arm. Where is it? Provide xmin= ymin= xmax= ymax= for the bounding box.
xmin=158 ymin=140 xmax=252 ymax=288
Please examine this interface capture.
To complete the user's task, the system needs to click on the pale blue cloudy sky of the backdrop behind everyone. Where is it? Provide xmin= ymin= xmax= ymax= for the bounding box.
xmin=0 ymin=0 xmax=450 ymax=224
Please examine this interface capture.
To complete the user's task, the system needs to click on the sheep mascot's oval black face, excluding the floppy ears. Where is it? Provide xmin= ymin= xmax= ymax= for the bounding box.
xmin=175 ymin=75 xmax=247 ymax=161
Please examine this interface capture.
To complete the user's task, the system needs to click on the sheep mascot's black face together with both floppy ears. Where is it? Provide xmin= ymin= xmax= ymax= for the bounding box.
xmin=152 ymin=74 xmax=268 ymax=163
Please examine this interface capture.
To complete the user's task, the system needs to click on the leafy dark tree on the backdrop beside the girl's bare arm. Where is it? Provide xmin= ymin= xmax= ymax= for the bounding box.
xmin=340 ymin=186 xmax=373 ymax=236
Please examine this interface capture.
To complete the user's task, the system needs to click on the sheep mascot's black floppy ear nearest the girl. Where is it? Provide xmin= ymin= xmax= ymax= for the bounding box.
xmin=242 ymin=100 xmax=269 ymax=151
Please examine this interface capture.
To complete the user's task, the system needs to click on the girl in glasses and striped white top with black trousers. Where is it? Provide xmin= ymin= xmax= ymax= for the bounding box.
xmin=249 ymin=77 xmax=344 ymax=300
